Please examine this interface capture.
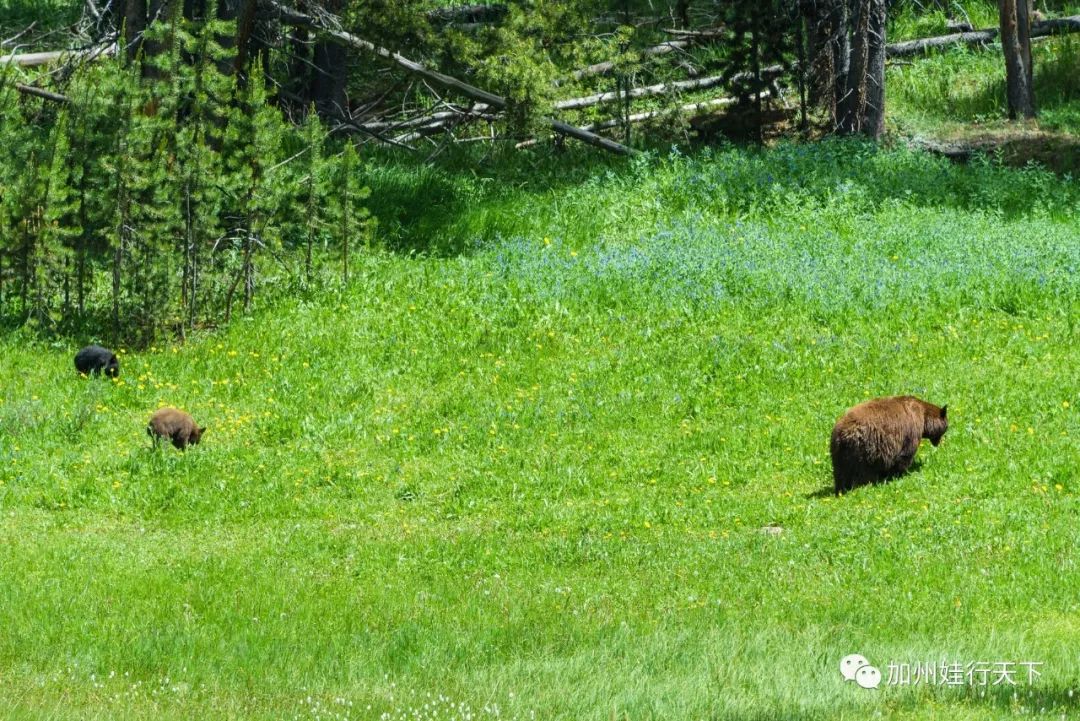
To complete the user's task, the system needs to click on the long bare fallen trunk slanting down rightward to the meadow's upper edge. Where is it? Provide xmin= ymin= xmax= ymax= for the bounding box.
xmin=266 ymin=0 xmax=631 ymax=155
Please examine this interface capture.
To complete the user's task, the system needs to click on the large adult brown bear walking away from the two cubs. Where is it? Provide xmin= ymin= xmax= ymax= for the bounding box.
xmin=829 ymin=395 xmax=948 ymax=495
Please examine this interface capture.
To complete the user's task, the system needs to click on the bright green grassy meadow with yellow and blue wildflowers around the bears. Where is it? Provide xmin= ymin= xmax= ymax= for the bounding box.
xmin=0 ymin=141 xmax=1080 ymax=721
